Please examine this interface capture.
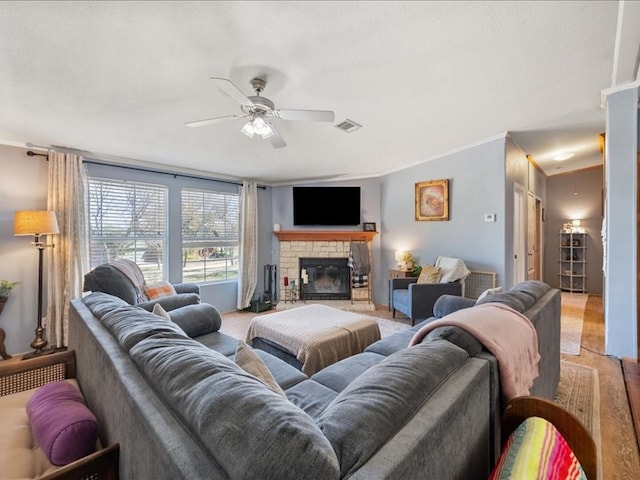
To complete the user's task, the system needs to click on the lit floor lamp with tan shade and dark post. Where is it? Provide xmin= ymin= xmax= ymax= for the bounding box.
xmin=13 ymin=210 xmax=60 ymax=359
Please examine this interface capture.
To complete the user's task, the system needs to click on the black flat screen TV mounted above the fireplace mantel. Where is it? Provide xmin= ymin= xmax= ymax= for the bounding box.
xmin=293 ymin=187 xmax=360 ymax=226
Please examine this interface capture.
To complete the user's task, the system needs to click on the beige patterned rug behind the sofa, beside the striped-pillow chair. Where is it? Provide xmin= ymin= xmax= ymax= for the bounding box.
xmin=555 ymin=360 xmax=602 ymax=478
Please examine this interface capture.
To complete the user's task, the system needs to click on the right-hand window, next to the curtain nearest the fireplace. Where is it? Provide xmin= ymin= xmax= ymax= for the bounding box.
xmin=182 ymin=188 xmax=239 ymax=282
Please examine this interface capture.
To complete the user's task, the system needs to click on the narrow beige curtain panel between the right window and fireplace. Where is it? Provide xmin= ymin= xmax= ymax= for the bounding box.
xmin=237 ymin=182 xmax=258 ymax=310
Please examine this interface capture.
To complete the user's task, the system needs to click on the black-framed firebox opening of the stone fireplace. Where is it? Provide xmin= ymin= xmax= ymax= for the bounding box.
xmin=299 ymin=258 xmax=351 ymax=300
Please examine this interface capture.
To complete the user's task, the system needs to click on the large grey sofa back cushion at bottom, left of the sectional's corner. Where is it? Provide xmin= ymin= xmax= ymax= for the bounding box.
xmin=130 ymin=336 xmax=339 ymax=480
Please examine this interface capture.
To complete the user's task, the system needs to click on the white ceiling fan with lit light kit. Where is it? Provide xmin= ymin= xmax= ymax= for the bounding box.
xmin=186 ymin=77 xmax=335 ymax=148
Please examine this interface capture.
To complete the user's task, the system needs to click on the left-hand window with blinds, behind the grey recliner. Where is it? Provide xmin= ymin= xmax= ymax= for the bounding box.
xmin=89 ymin=178 xmax=168 ymax=283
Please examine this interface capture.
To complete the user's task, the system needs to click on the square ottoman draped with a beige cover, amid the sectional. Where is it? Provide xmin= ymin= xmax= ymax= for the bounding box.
xmin=247 ymin=305 xmax=380 ymax=376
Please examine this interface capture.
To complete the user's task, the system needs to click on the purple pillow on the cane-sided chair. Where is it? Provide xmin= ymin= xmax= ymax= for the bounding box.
xmin=27 ymin=381 xmax=98 ymax=466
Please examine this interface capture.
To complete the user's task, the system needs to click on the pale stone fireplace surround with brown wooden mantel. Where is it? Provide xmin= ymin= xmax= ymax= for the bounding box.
xmin=274 ymin=230 xmax=377 ymax=310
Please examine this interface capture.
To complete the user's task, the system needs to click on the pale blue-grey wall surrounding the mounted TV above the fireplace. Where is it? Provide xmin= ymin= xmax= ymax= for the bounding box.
xmin=271 ymin=178 xmax=380 ymax=303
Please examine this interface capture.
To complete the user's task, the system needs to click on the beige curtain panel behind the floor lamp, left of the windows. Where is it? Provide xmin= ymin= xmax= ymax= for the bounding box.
xmin=45 ymin=150 xmax=89 ymax=347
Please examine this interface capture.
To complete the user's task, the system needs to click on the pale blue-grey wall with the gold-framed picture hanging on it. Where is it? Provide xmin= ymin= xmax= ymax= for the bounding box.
xmin=377 ymin=138 xmax=507 ymax=303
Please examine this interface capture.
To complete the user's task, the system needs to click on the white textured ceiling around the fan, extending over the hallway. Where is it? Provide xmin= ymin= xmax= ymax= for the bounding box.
xmin=0 ymin=1 xmax=640 ymax=184
